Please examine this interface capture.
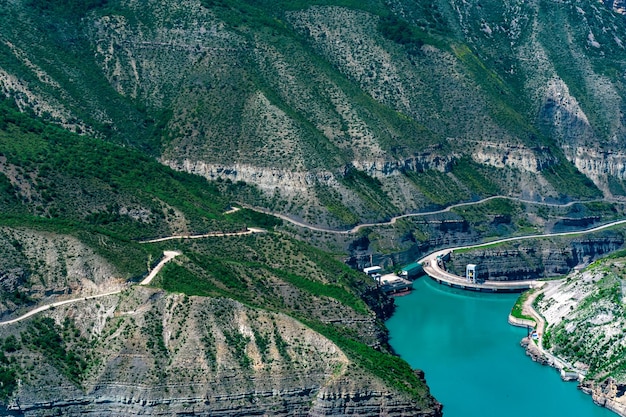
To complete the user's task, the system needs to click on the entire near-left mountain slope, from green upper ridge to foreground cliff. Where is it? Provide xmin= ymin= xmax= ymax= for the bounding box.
xmin=0 ymin=101 xmax=441 ymax=416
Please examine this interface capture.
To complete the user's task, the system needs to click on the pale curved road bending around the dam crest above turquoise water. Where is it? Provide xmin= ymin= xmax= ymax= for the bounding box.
xmin=418 ymin=216 xmax=626 ymax=291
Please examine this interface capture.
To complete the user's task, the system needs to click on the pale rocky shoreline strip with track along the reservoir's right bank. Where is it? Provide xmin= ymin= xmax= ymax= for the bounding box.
xmin=508 ymin=280 xmax=626 ymax=417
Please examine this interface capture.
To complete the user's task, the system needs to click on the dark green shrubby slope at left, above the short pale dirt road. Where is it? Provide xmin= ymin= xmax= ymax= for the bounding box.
xmin=0 ymin=97 xmax=254 ymax=240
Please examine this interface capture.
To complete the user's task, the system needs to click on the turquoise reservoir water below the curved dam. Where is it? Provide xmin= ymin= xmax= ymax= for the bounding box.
xmin=387 ymin=278 xmax=617 ymax=417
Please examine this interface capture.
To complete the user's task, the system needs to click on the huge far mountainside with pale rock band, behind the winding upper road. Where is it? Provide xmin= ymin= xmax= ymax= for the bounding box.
xmin=0 ymin=0 xmax=626 ymax=227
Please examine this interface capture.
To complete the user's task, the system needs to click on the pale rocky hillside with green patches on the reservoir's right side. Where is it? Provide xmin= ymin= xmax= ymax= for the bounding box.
xmin=534 ymin=251 xmax=626 ymax=415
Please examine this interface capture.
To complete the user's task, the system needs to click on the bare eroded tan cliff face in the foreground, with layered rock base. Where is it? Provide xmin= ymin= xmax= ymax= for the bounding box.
xmin=0 ymin=288 xmax=437 ymax=416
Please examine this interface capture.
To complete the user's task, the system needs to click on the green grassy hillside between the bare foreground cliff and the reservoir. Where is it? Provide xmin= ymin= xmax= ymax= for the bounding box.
xmin=150 ymin=235 xmax=426 ymax=397
